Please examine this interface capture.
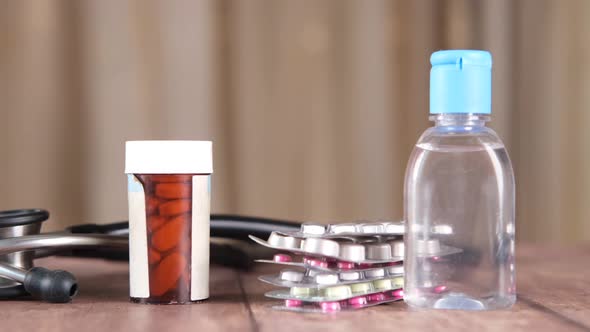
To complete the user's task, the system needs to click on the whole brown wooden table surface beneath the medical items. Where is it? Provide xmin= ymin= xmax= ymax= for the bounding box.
xmin=0 ymin=246 xmax=590 ymax=332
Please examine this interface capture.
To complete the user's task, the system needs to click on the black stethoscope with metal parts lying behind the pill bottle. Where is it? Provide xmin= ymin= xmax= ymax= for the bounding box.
xmin=0 ymin=209 xmax=300 ymax=303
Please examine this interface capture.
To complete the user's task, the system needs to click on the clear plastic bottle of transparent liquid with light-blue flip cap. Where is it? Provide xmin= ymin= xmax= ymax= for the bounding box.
xmin=404 ymin=50 xmax=516 ymax=310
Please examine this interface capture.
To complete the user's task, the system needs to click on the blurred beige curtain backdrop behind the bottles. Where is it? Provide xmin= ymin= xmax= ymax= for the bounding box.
xmin=0 ymin=0 xmax=590 ymax=242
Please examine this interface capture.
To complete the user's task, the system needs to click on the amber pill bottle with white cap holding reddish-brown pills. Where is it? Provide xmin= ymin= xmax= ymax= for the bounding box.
xmin=125 ymin=141 xmax=213 ymax=304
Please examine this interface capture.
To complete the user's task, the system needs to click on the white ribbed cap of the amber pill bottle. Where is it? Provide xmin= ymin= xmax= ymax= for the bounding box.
xmin=125 ymin=141 xmax=213 ymax=174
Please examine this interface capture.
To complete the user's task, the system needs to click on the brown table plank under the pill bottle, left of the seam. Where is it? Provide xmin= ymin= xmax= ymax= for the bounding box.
xmin=0 ymin=258 xmax=251 ymax=332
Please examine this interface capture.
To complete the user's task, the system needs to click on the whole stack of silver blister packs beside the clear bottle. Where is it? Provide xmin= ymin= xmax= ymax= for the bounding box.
xmin=250 ymin=222 xmax=412 ymax=312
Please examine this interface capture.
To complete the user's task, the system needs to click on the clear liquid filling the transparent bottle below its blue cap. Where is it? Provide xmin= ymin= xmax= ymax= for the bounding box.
xmin=405 ymin=118 xmax=515 ymax=310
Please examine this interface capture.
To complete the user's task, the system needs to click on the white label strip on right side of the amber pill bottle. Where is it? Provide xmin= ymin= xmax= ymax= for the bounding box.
xmin=191 ymin=175 xmax=211 ymax=301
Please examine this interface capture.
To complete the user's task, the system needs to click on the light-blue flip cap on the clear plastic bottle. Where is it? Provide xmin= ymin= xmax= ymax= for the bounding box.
xmin=430 ymin=50 xmax=492 ymax=114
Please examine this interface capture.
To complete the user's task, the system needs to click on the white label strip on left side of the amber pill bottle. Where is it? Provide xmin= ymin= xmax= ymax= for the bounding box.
xmin=127 ymin=174 xmax=150 ymax=298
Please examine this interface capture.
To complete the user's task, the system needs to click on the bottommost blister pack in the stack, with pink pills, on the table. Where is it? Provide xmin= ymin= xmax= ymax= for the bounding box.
xmin=273 ymin=289 xmax=403 ymax=313
